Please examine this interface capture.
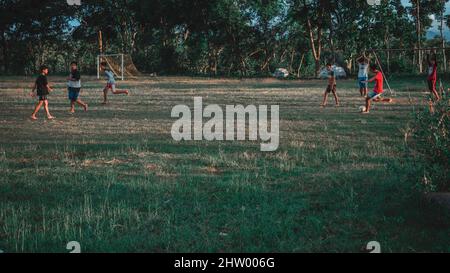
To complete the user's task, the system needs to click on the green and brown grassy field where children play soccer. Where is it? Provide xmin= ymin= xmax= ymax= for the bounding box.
xmin=0 ymin=77 xmax=450 ymax=252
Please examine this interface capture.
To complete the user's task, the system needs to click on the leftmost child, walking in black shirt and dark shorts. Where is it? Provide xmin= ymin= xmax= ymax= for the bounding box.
xmin=30 ymin=65 xmax=55 ymax=120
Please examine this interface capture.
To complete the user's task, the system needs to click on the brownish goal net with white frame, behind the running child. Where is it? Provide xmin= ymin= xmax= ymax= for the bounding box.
xmin=97 ymin=54 xmax=141 ymax=80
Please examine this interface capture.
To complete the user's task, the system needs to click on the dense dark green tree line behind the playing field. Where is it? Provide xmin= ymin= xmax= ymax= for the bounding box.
xmin=0 ymin=0 xmax=448 ymax=77
